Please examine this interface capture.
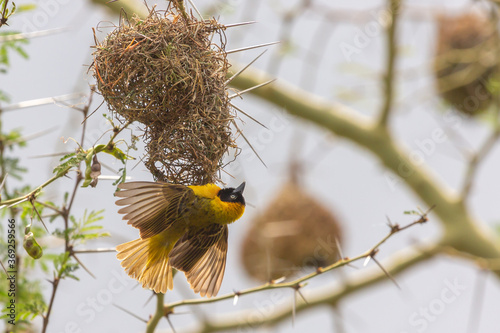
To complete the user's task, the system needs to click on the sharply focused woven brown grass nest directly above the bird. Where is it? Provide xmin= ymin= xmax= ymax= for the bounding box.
xmin=92 ymin=8 xmax=235 ymax=185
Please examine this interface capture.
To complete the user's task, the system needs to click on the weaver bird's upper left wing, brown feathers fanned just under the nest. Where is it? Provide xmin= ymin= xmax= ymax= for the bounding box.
xmin=115 ymin=182 xmax=194 ymax=239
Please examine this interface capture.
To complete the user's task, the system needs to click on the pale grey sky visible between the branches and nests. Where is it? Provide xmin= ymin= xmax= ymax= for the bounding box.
xmin=0 ymin=0 xmax=500 ymax=333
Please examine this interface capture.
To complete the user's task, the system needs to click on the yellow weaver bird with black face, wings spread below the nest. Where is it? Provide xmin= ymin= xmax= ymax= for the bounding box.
xmin=115 ymin=182 xmax=245 ymax=297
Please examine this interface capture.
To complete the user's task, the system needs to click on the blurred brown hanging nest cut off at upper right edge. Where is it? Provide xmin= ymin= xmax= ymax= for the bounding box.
xmin=434 ymin=13 xmax=500 ymax=115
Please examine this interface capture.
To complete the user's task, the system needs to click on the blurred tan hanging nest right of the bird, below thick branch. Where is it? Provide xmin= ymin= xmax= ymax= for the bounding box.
xmin=241 ymin=181 xmax=342 ymax=282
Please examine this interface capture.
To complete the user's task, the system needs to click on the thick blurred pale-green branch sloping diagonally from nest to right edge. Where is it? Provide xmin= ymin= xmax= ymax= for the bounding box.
xmin=232 ymin=63 xmax=500 ymax=264
